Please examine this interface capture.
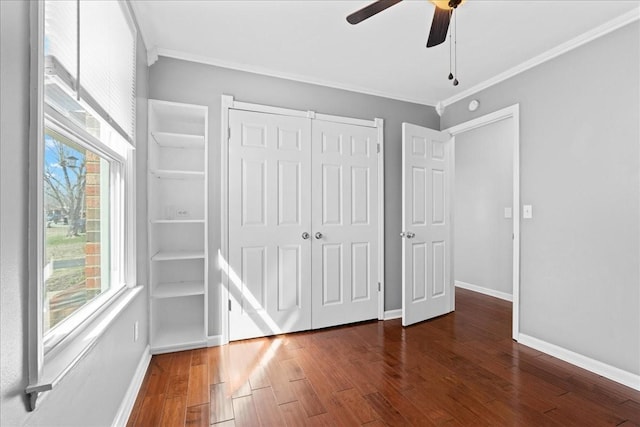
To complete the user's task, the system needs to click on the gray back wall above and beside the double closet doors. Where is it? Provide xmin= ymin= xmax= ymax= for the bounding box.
xmin=150 ymin=58 xmax=439 ymax=334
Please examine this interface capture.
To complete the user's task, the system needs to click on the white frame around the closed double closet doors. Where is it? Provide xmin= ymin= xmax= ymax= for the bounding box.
xmin=219 ymin=95 xmax=385 ymax=346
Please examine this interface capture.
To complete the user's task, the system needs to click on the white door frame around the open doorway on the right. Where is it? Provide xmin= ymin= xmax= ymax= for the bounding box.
xmin=444 ymin=104 xmax=521 ymax=341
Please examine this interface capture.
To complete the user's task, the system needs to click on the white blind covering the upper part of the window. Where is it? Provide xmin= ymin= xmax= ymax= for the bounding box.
xmin=45 ymin=0 xmax=136 ymax=142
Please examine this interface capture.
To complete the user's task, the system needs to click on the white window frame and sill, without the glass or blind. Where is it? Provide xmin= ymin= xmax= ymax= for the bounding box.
xmin=25 ymin=1 xmax=142 ymax=411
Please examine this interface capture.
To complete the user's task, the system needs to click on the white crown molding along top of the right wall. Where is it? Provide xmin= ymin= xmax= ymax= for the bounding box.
xmin=437 ymin=7 xmax=640 ymax=109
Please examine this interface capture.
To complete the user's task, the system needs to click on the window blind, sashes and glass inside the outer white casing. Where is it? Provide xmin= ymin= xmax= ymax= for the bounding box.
xmin=41 ymin=0 xmax=135 ymax=354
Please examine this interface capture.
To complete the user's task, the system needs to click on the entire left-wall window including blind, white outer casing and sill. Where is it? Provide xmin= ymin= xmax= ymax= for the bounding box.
xmin=27 ymin=0 xmax=137 ymax=409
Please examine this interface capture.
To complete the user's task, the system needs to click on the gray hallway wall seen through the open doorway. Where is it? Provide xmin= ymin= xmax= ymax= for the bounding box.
xmin=454 ymin=119 xmax=514 ymax=295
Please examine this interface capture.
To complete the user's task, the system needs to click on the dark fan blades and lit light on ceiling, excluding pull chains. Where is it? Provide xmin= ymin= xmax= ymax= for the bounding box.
xmin=347 ymin=0 xmax=463 ymax=47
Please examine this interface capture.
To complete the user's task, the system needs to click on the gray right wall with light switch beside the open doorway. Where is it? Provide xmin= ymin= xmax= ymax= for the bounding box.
xmin=441 ymin=21 xmax=640 ymax=374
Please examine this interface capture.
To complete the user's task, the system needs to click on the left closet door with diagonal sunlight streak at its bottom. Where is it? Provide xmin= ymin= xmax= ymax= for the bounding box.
xmin=228 ymin=110 xmax=311 ymax=340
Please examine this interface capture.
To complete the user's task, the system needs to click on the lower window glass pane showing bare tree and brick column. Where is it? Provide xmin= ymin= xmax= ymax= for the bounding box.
xmin=43 ymin=128 xmax=112 ymax=333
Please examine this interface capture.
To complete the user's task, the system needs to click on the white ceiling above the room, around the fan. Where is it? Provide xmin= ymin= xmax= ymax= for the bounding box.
xmin=132 ymin=0 xmax=640 ymax=105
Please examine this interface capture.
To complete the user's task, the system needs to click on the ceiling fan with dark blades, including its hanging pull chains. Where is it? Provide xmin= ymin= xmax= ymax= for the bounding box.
xmin=347 ymin=0 xmax=464 ymax=86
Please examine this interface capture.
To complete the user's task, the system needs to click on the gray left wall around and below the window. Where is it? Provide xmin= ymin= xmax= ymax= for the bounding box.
xmin=0 ymin=0 xmax=148 ymax=426
